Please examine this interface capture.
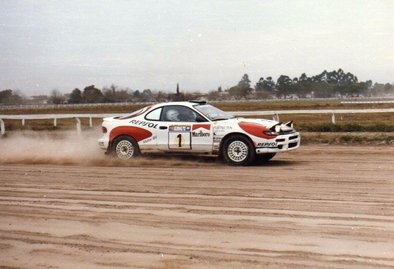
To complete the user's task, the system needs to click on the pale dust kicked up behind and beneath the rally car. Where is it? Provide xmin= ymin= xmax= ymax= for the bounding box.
xmin=0 ymin=130 xmax=218 ymax=167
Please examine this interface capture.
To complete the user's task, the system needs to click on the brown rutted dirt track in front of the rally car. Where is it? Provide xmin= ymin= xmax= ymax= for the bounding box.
xmin=0 ymin=145 xmax=394 ymax=269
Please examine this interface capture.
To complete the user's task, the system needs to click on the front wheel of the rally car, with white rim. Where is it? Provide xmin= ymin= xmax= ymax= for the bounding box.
xmin=221 ymin=135 xmax=256 ymax=165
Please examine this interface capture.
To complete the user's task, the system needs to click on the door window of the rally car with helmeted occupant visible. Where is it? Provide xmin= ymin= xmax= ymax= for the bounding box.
xmin=162 ymin=106 xmax=205 ymax=122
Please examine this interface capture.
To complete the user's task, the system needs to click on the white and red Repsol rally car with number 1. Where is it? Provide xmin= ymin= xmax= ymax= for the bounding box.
xmin=99 ymin=101 xmax=300 ymax=165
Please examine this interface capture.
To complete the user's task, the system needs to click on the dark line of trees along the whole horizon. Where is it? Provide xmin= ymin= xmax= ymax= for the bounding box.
xmin=0 ymin=69 xmax=394 ymax=105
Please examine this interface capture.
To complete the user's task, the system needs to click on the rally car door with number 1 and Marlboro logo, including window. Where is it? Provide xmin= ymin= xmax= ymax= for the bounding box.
xmin=157 ymin=105 xmax=213 ymax=152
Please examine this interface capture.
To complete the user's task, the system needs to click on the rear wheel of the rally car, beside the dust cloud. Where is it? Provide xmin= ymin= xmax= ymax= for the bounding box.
xmin=112 ymin=136 xmax=140 ymax=160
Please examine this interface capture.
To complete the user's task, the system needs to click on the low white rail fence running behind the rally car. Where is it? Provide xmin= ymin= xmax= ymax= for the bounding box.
xmin=0 ymin=108 xmax=394 ymax=135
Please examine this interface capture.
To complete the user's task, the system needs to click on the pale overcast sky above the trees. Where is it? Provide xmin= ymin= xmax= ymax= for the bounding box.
xmin=0 ymin=0 xmax=394 ymax=95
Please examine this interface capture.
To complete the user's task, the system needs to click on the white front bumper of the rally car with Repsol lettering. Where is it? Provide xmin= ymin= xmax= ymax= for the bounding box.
xmin=256 ymin=132 xmax=301 ymax=154
